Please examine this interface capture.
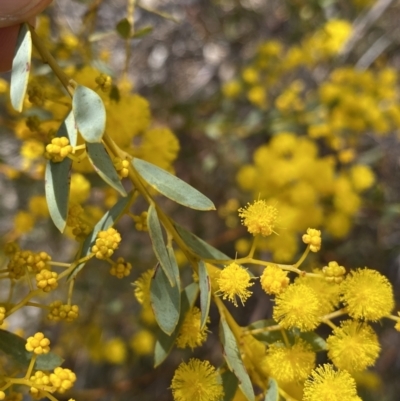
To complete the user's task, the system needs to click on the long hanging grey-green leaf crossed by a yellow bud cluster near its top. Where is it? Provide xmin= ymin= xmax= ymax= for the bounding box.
xmin=44 ymin=111 xmax=78 ymax=232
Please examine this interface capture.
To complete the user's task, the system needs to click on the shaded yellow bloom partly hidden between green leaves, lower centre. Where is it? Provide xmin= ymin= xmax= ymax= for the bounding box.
xmin=176 ymin=306 xmax=210 ymax=350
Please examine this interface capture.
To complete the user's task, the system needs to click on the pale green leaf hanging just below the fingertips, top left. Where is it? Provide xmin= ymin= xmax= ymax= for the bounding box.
xmin=10 ymin=24 xmax=32 ymax=112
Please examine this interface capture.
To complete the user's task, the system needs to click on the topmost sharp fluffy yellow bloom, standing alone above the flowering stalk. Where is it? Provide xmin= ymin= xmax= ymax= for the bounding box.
xmin=239 ymin=200 xmax=278 ymax=237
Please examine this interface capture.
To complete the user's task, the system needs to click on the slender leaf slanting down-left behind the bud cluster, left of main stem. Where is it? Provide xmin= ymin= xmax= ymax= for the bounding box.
xmin=68 ymin=191 xmax=133 ymax=280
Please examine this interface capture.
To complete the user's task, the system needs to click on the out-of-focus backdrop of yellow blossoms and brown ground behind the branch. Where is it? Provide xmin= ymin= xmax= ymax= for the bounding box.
xmin=0 ymin=0 xmax=400 ymax=401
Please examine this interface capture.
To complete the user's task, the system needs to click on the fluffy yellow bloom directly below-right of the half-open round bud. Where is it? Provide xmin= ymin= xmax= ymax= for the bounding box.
xmin=273 ymin=283 xmax=321 ymax=331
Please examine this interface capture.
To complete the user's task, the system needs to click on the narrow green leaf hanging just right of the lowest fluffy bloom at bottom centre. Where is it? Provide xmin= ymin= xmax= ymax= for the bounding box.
xmin=220 ymin=316 xmax=255 ymax=401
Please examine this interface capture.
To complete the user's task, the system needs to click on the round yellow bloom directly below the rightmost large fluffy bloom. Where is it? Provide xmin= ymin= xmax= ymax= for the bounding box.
xmin=327 ymin=320 xmax=380 ymax=373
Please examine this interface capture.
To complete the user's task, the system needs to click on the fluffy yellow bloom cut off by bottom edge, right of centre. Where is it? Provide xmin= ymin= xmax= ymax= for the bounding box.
xmin=303 ymin=364 xmax=359 ymax=401
